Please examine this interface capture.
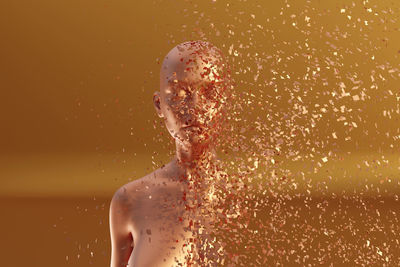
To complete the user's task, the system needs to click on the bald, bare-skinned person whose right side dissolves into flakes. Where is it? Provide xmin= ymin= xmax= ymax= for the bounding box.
xmin=110 ymin=41 xmax=230 ymax=267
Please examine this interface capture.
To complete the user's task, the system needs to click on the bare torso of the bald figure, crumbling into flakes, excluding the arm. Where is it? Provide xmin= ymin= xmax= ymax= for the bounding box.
xmin=123 ymin=166 xmax=198 ymax=267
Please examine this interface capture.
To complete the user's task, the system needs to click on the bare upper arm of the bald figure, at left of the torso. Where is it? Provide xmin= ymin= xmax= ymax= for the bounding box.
xmin=110 ymin=188 xmax=133 ymax=267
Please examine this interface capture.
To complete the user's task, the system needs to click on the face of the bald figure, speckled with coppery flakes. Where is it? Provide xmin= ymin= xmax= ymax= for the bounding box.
xmin=154 ymin=42 xmax=230 ymax=148
